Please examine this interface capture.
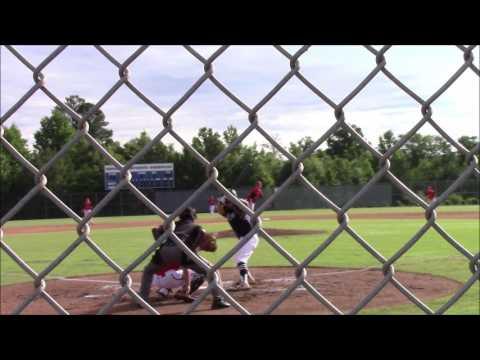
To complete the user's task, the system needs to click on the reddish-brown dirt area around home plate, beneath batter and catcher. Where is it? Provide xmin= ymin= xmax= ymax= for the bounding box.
xmin=0 ymin=267 xmax=461 ymax=315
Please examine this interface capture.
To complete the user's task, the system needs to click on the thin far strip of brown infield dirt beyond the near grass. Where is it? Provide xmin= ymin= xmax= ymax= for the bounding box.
xmin=4 ymin=211 xmax=479 ymax=235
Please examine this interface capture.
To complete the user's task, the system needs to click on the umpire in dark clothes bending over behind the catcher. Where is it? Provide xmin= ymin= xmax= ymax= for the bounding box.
xmin=139 ymin=207 xmax=230 ymax=309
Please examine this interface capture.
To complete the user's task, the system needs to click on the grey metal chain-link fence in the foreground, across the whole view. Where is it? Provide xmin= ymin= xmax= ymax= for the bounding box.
xmin=0 ymin=45 xmax=480 ymax=314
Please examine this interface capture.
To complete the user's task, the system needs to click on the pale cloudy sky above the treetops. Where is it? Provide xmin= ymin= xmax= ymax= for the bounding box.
xmin=0 ymin=45 xmax=480 ymax=153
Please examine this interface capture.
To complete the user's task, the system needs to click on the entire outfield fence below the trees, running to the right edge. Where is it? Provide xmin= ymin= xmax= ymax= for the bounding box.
xmin=0 ymin=179 xmax=479 ymax=220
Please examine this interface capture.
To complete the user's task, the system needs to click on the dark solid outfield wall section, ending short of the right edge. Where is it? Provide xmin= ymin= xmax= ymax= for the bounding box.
xmin=0 ymin=184 xmax=394 ymax=220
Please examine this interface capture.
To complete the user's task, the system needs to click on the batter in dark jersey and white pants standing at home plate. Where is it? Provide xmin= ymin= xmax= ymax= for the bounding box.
xmin=217 ymin=190 xmax=258 ymax=290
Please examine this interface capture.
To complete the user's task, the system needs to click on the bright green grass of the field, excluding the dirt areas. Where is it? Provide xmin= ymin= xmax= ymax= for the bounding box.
xmin=0 ymin=206 xmax=480 ymax=314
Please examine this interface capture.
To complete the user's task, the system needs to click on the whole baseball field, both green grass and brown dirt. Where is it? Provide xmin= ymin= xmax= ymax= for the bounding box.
xmin=0 ymin=206 xmax=480 ymax=315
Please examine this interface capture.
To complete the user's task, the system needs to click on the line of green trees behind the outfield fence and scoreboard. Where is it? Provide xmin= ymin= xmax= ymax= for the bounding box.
xmin=0 ymin=96 xmax=478 ymax=200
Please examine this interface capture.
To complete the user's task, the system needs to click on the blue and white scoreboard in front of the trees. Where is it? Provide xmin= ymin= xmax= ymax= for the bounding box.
xmin=104 ymin=163 xmax=175 ymax=190
